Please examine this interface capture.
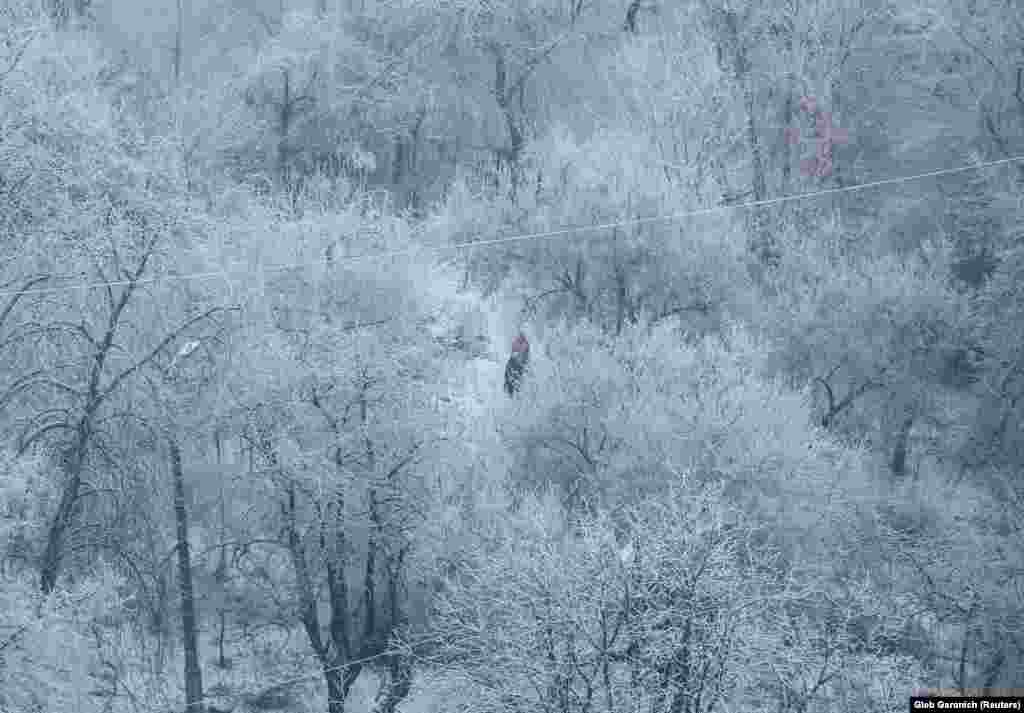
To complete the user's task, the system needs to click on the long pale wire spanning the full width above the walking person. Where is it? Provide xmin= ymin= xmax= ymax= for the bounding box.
xmin=0 ymin=155 xmax=1024 ymax=298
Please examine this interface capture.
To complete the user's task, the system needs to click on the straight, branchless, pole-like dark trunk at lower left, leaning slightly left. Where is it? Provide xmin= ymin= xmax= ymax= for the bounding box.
xmin=170 ymin=438 xmax=203 ymax=713
